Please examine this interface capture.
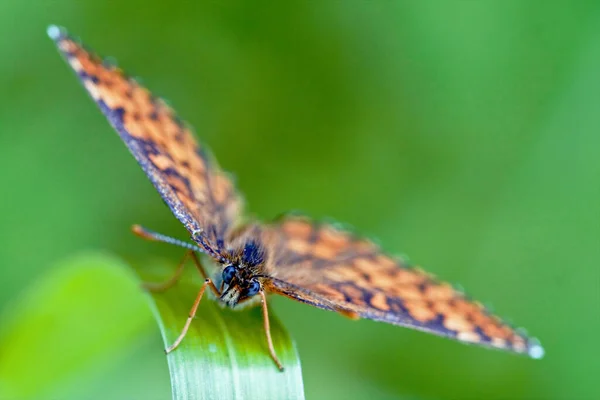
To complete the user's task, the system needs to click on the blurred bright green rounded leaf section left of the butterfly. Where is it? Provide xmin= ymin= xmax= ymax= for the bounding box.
xmin=0 ymin=253 xmax=158 ymax=399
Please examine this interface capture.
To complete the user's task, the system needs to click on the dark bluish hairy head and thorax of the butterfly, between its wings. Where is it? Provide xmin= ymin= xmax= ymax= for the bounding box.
xmin=219 ymin=242 xmax=264 ymax=308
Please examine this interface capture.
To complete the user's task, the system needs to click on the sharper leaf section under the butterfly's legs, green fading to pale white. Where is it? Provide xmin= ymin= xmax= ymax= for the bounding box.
xmin=127 ymin=261 xmax=304 ymax=399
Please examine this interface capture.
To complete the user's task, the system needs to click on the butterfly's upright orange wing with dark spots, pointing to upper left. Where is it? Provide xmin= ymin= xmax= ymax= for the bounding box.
xmin=48 ymin=26 xmax=243 ymax=258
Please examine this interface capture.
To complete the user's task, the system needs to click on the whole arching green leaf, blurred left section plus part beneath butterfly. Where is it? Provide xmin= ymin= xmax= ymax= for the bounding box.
xmin=0 ymin=253 xmax=304 ymax=399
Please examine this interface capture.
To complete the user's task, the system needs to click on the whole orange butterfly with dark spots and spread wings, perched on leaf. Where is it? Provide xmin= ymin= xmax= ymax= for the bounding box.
xmin=48 ymin=26 xmax=544 ymax=370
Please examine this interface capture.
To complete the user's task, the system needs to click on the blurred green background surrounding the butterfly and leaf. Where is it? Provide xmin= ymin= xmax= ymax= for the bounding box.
xmin=0 ymin=0 xmax=600 ymax=399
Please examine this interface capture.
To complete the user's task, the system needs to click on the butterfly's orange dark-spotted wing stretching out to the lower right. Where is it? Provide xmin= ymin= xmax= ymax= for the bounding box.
xmin=262 ymin=217 xmax=542 ymax=357
